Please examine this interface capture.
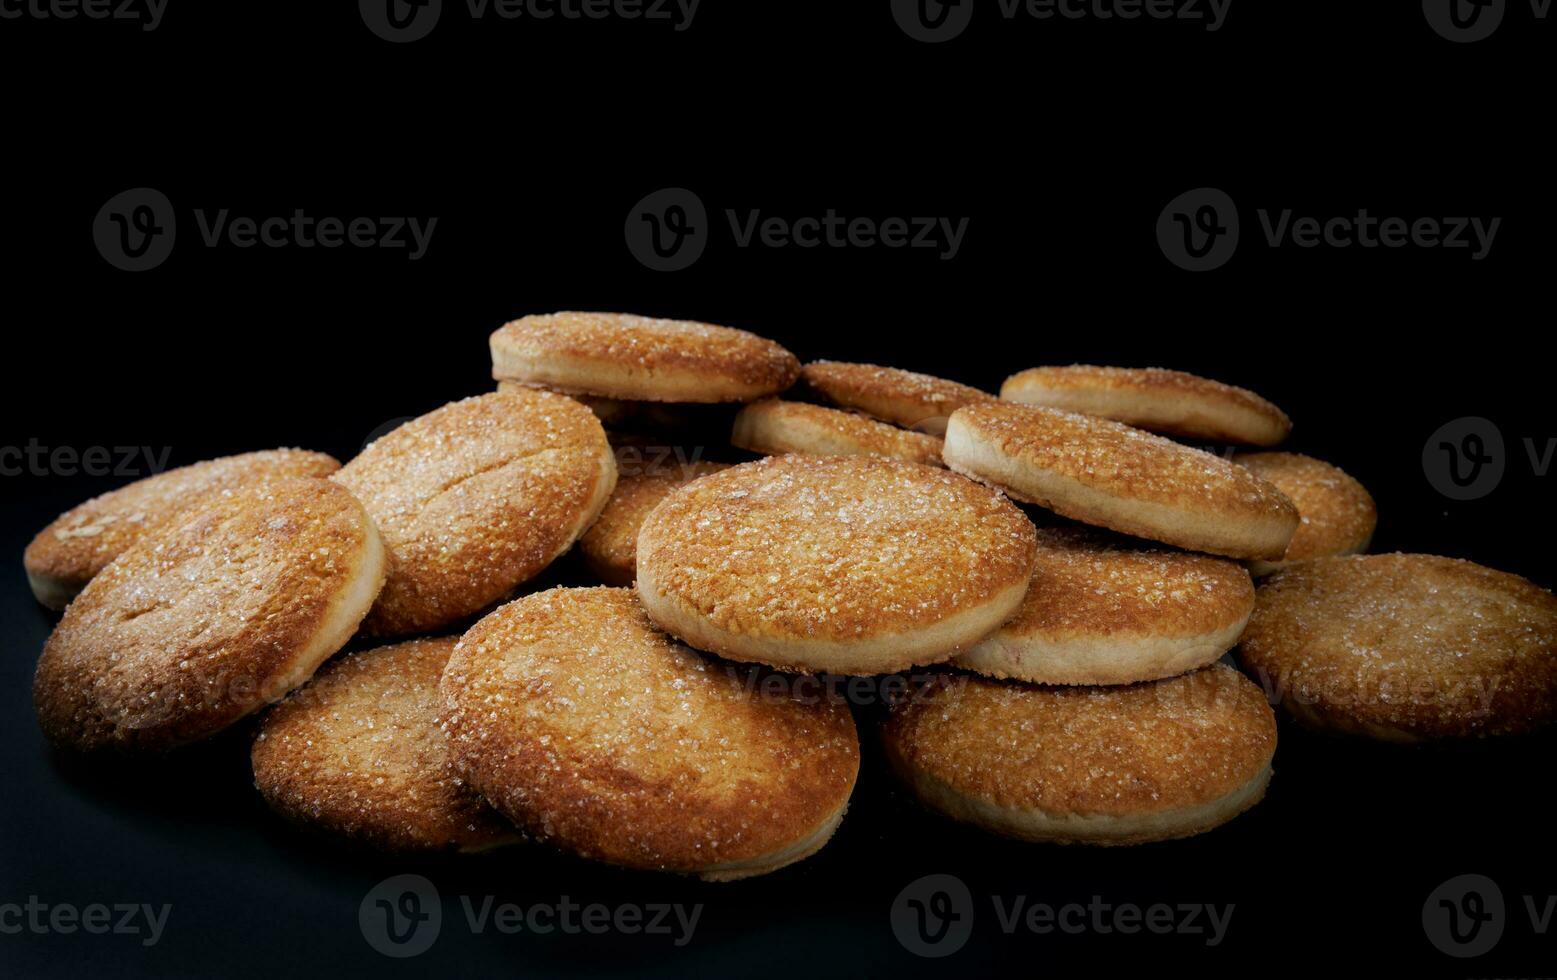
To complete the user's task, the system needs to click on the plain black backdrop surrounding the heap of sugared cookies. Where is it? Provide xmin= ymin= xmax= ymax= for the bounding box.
xmin=0 ymin=0 xmax=1557 ymax=977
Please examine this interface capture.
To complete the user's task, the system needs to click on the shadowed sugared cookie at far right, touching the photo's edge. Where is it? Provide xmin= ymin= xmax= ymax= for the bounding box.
xmin=1239 ymin=555 xmax=1557 ymax=742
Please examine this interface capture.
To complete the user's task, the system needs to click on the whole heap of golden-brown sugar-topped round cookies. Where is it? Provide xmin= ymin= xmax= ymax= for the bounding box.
xmin=25 ymin=313 xmax=1557 ymax=880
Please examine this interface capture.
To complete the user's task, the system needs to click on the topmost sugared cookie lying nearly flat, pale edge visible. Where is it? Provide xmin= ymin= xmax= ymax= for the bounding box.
xmin=490 ymin=313 xmax=800 ymax=402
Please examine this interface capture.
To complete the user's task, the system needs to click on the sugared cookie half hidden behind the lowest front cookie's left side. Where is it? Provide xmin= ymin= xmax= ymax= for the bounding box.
xmin=249 ymin=637 xmax=518 ymax=851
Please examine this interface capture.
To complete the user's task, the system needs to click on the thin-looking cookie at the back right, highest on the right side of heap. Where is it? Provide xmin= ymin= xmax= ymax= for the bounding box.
xmin=1000 ymin=365 xmax=1292 ymax=446
